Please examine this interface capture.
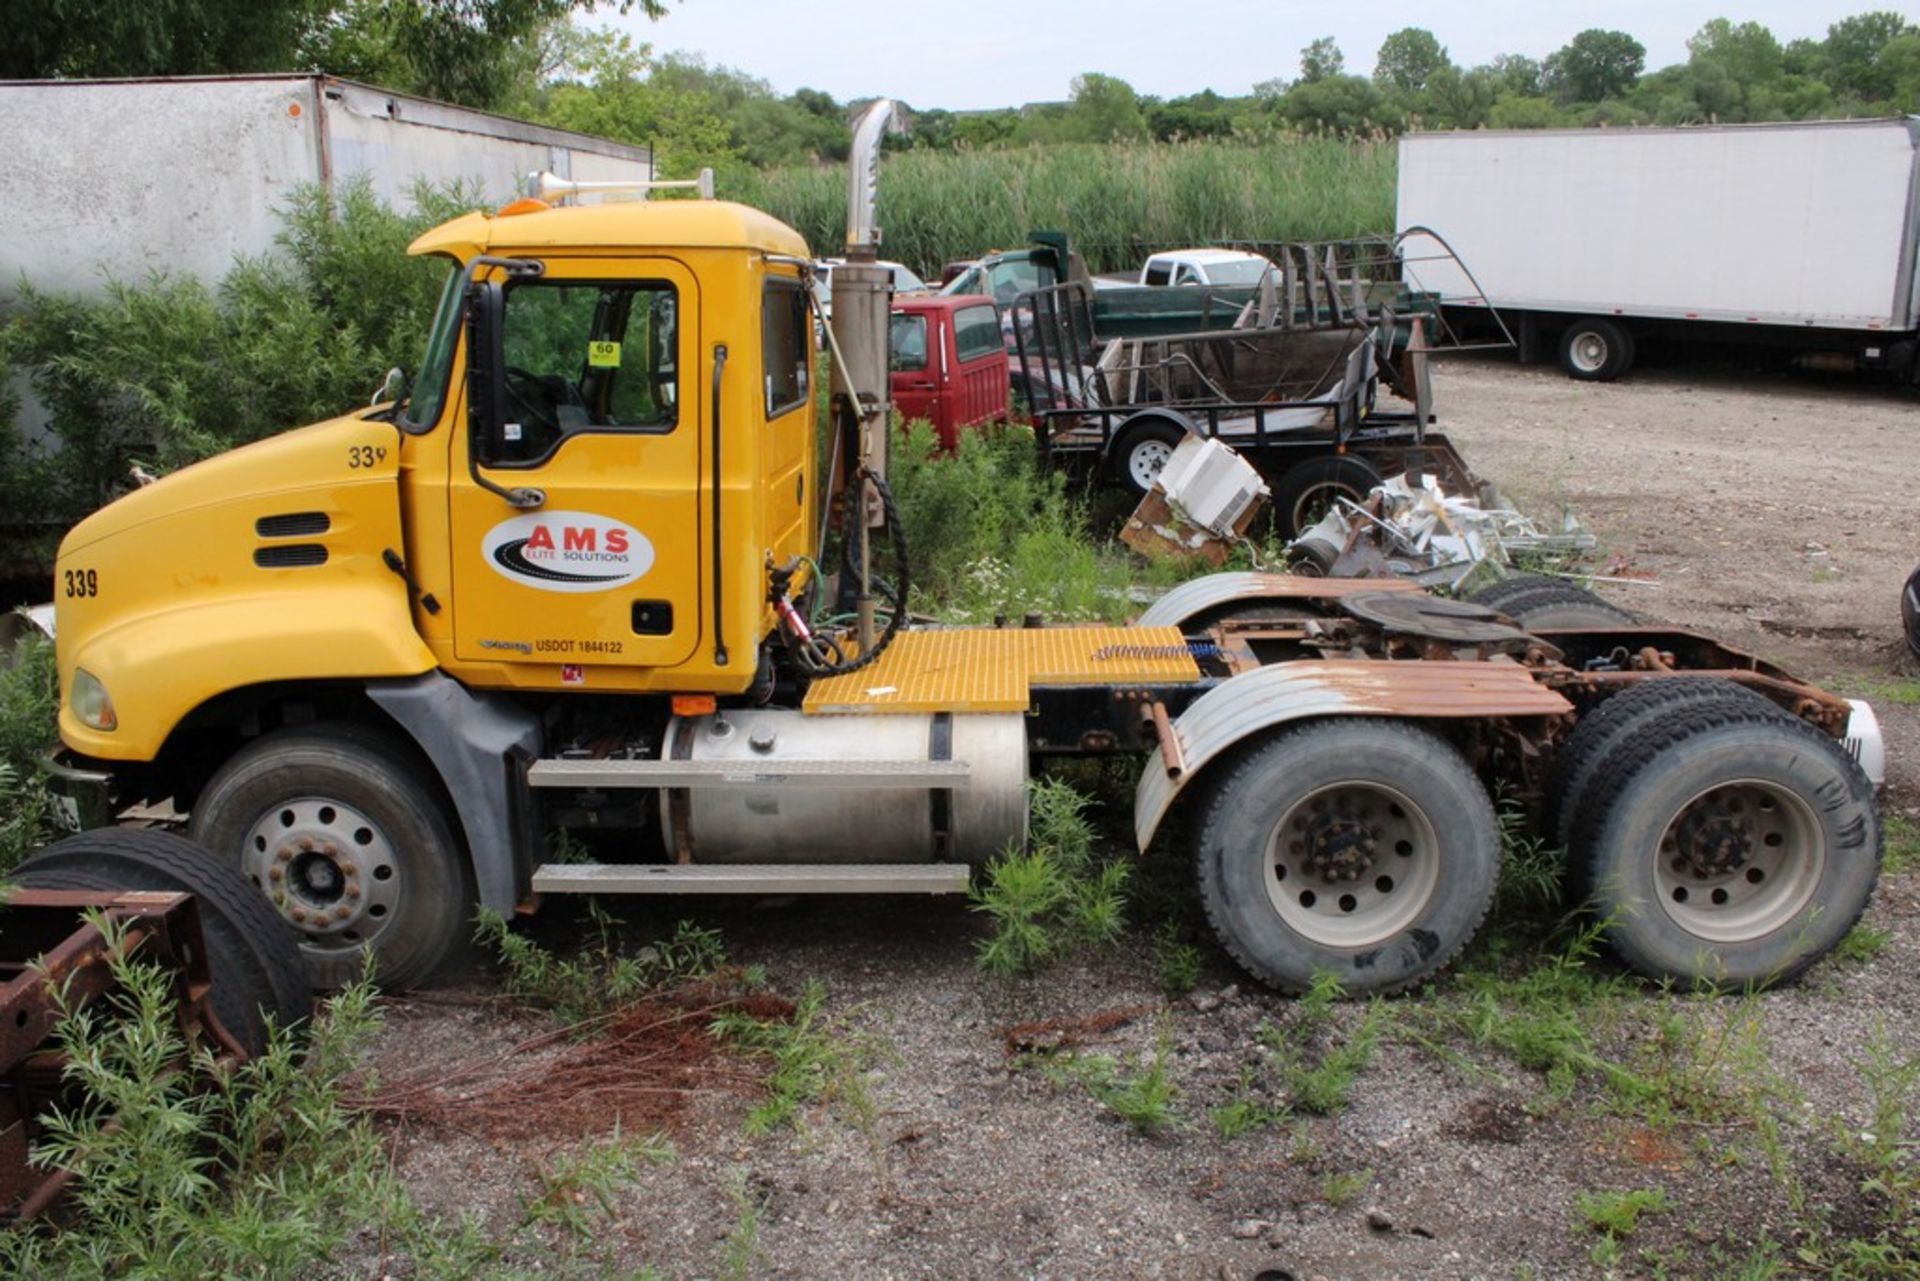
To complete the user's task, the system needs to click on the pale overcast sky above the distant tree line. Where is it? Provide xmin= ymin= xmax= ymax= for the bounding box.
xmin=599 ymin=0 xmax=1912 ymax=109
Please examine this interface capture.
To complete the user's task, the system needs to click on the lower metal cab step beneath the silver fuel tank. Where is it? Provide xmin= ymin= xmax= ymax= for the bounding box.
xmin=534 ymin=862 xmax=973 ymax=895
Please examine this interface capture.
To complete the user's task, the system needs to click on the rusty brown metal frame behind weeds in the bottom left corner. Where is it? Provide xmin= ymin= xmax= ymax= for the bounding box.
xmin=0 ymin=889 xmax=248 ymax=1225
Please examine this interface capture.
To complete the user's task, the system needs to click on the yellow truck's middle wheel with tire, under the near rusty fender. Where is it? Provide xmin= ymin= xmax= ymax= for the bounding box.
xmin=1194 ymin=718 xmax=1500 ymax=995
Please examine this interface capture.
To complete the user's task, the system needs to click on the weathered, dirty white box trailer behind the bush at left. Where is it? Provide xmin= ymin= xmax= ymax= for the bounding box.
xmin=0 ymin=75 xmax=653 ymax=309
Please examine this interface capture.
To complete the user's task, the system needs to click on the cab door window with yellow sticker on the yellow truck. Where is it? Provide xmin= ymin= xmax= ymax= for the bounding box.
xmin=482 ymin=280 xmax=678 ymax=465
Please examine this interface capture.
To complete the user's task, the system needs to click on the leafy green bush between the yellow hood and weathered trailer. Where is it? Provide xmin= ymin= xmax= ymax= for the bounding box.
xmin=0 ymin=181 xmax=472 ymax=559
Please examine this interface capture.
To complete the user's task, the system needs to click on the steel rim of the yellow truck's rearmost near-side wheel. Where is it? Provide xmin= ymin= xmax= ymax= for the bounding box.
xmin=1653 ymin=778 xmax=1830 ymax=943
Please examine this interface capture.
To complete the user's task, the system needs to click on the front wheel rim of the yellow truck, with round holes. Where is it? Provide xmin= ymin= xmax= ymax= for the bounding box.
xmin=240 ymin=797 xmax=401 ymax=953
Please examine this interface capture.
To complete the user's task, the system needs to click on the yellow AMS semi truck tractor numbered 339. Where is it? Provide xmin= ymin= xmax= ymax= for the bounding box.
xmin=41 ymin=120 xmax=1880 ymax=991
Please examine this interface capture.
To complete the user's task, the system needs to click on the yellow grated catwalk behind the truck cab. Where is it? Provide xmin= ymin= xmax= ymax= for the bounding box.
xmin=806 ymin=628 xmax=1200 ymax=713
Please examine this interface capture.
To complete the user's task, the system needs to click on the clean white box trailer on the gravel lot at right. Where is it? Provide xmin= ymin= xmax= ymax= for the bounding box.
xmin=1396 ymin=117 xmax=1920 ymax=378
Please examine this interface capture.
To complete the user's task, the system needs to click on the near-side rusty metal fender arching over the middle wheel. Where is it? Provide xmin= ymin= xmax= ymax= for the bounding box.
xmin=1133 ymin=660 xmax=1572 ymax=855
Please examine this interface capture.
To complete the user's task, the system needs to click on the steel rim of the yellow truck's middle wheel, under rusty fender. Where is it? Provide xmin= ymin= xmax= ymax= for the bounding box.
xmin=1265 ymin=782 xmax=1440 ymax=949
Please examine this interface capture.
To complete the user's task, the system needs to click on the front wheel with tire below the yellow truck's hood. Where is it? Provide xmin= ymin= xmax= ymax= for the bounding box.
xmin=192 ymin=724 xmax=472 ymax=991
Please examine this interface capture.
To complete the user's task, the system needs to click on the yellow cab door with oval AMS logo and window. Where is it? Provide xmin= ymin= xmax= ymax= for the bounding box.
xmin=447 ymin=259 xmax=705 ymax=684
